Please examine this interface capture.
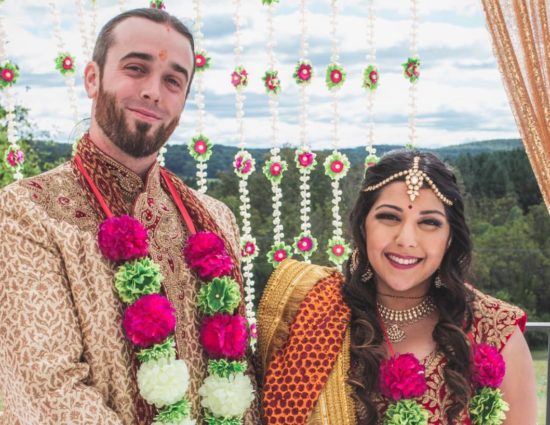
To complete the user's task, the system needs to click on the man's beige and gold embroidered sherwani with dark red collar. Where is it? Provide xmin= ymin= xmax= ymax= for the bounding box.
xmin=0 ymin=138 xmax=259 ymax=425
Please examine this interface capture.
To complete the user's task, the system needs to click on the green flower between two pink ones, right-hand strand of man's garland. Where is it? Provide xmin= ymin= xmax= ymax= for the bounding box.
xmin=198 ymin=276 xmax=241 ymax=314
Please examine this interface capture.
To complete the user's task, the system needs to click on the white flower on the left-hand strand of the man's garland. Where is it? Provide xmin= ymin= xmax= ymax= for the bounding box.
xmin=137 ymin=358 xmax=189 ymax=407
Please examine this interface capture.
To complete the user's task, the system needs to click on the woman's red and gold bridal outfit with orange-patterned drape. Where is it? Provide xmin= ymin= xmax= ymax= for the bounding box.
xmin=258 ymin=260 xmax=526 ymax=425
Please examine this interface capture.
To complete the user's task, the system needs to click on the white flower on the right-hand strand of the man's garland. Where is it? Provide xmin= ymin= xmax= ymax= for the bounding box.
xmin=199 ymin=373 xmax=254 ymax=417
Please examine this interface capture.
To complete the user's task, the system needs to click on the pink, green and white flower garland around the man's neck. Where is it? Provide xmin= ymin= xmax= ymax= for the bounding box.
xmin=75 ymin=156 xmax=254 ymax=425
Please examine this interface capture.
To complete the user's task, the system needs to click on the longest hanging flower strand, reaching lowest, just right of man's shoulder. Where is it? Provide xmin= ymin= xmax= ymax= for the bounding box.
xmin=231 ymin=0 xmax=259 ymax=352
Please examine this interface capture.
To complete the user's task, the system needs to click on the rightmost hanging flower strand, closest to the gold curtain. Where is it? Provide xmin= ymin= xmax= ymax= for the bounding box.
xmin=408 ymin=0 xmax=420 ymax=149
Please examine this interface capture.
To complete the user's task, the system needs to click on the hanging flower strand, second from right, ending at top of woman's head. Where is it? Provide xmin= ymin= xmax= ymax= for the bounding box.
xmin=363 ymin=0 xmax=380 ymax=168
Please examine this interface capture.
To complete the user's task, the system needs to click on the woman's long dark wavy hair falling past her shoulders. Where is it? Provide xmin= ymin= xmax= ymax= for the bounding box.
xmin=343 ymin=150 xmax=473 ymax=425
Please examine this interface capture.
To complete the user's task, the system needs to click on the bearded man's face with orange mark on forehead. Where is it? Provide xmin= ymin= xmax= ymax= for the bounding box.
xmin=94 ymin=18 xmax=193 ymax=158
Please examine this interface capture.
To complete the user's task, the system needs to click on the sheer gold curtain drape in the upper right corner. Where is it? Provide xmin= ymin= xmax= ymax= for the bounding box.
xmin=481 ymin=0 xmax=550 ymax=212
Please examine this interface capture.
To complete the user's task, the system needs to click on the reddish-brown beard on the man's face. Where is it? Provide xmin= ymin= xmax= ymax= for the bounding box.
xmin=95 ymin=86 xmax=179 ymax=158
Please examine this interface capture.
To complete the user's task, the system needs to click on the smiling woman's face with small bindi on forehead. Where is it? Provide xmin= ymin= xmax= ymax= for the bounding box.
xmin=365 ymin=182 xmax=450 ymax=295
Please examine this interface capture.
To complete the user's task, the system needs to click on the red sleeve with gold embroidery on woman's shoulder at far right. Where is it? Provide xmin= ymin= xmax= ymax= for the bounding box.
xmin=472 ymin=288 xmax=527 ymax=351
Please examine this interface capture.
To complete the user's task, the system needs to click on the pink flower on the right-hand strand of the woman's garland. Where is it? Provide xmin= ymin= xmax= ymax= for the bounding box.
xmin=472 ymin=344 xmax=506 ymax=388
